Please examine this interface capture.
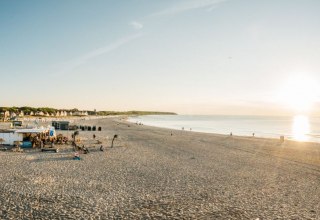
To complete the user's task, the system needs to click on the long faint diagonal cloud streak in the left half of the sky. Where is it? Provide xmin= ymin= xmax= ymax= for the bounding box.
xmin=56 ymin=33 xmax=142 ymax=75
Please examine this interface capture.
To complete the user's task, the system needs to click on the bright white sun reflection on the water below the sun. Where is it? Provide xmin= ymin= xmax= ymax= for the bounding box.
xmin=292 ymin=115 xmax=310 ymax=141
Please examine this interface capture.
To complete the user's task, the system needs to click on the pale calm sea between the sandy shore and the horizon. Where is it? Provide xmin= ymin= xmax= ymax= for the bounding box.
xmin=129 ymin=115 xmax=320 ymax=142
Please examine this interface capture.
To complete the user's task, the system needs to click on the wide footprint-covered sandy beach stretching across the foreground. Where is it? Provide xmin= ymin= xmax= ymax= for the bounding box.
xmin=0 ymin=118 xmax=320 ymax=219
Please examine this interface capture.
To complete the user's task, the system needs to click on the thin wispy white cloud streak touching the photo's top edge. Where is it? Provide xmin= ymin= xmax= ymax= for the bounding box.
xmin=152 ymin=0 xmax=227 ymax=16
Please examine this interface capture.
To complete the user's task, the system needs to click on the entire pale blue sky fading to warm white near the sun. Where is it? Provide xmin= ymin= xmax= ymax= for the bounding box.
xmin=0 ymin=0 xmax=320 ymax=115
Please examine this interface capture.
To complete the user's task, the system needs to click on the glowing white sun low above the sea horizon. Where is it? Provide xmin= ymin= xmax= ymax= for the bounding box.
xmin=280 ymin=75 xmax=319 ymax=112
